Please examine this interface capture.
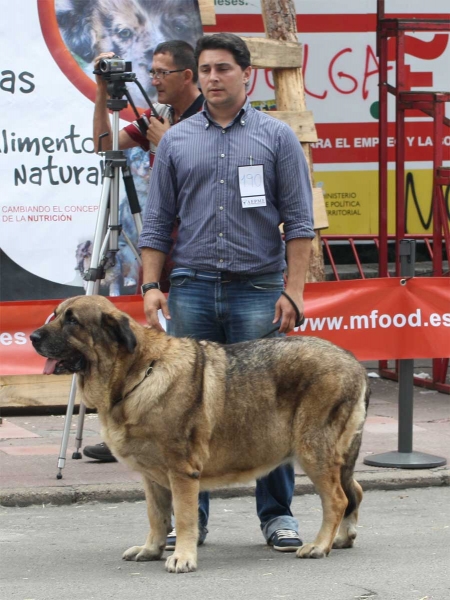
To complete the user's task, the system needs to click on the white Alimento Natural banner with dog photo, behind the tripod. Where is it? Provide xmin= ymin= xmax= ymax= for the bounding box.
xmin=0 ymin=0 xmax=202 ymax=300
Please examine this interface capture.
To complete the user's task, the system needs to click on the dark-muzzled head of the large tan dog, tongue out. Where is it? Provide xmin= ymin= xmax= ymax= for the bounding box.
xmin=30 ymin=296 xmax=137 ymax=375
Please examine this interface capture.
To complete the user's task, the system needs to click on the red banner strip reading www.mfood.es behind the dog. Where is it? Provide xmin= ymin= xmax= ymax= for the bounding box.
xmin=0 ymin=277 xmax=450 ymax=375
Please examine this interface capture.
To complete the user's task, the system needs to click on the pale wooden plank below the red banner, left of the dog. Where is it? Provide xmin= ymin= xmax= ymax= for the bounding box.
xmin=0 ymin=375 xmax=79 ymax=408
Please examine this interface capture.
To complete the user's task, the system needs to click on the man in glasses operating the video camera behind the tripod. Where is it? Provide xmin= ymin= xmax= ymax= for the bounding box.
xmin=83 ymin=40 xmax=204 ymax=462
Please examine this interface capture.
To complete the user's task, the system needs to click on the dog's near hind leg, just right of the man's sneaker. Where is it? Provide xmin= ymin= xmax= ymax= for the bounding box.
xmin=297 ymin=454 xmax=347 ymax=558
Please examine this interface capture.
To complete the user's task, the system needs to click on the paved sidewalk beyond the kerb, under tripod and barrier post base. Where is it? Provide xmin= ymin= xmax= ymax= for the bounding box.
xmin=0 ymin=361 xmax=450 ymax=506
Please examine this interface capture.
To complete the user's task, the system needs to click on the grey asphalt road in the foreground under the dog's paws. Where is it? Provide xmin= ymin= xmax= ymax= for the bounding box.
xmin=0 ymin=487 xmax=450 ymax=600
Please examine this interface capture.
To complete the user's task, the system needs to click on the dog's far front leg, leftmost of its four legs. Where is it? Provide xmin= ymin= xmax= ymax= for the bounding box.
xmin=122 ymin=477 xmax=172 ymax=560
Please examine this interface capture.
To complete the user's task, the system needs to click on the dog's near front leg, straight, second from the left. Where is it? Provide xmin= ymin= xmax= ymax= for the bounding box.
xmin=166 ymin=473 xmax=200 ymax=573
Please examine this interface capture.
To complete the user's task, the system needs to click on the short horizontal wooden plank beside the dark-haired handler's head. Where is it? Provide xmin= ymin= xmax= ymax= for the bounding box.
xmin=242 ymin=36 xmax=303 ymax=69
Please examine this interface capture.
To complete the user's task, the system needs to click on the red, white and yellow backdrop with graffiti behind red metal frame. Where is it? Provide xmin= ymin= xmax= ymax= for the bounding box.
xmin=207 ymin=0 xmax=450 ymax=235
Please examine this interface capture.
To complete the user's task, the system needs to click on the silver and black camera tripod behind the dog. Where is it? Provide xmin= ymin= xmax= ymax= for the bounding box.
xmin=56 ymin=73 xmax=146 ymax=479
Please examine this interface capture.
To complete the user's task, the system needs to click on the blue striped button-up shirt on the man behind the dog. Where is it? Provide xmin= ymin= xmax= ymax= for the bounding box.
xmin=139 ymin=100 xmax=314 ymax=274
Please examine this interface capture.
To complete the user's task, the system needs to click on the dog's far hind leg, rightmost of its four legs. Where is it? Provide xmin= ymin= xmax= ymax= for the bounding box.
xmin=333 ymin=433 xmax=363 ymax=548
